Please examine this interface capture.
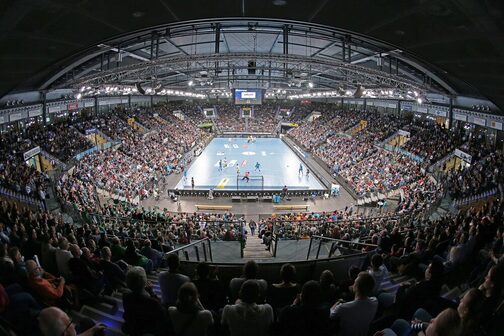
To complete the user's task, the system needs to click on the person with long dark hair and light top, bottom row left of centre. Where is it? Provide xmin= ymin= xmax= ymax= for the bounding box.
xmin=168 ymin=282 xmax=214 ymax=335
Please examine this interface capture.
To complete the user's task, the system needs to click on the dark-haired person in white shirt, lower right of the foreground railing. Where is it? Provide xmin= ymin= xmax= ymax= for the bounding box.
xmin=330 ymin=272 xmax=378 ymax=336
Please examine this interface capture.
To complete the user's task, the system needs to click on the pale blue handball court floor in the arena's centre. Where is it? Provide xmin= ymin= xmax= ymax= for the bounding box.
xmin=176 ymin=138 xmax=325 ymax=190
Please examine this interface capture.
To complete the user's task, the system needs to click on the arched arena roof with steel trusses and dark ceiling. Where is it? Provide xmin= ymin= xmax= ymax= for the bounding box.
xmin=0 ymin=0 xmax=504 ymax=109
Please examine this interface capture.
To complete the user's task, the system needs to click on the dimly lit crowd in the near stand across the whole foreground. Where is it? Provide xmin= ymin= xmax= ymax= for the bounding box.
xmin=0 ymin=194 xmax=504 ymax=336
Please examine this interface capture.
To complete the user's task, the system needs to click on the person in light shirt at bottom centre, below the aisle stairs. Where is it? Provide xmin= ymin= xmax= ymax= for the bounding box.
xmin=221 ymin=280 xmax=273 ymax=336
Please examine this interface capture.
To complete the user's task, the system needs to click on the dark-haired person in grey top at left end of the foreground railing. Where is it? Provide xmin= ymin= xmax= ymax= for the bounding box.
xmin=159 ymin=253 xmax=190 ymax=307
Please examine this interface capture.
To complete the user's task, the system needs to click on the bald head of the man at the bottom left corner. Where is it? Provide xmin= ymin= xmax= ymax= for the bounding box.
xmin=38 ymin=307 xmax=77 ymax=336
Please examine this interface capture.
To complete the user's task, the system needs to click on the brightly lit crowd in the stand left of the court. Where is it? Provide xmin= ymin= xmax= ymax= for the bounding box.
xmin=60 ymin=106 xmax=211 ymax=205
